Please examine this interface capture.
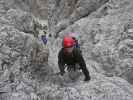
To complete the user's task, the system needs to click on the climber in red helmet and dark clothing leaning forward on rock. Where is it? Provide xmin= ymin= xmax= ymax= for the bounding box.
xmin=58 ymin=36 xmax=90 ymax=81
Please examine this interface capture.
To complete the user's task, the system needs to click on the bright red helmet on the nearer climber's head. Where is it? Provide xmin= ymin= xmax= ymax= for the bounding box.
xmin=63 ymin=36 xmax=75 ymax=48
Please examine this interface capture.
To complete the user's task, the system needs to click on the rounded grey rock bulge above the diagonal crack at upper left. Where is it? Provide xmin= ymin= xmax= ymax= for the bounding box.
xmin=6 ymin=9 xmax=34 ymax=33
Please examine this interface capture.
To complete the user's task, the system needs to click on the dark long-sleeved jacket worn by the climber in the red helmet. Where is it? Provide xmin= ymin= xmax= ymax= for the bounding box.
xmin=58 ymin=48 xmax=90 ymax=78
